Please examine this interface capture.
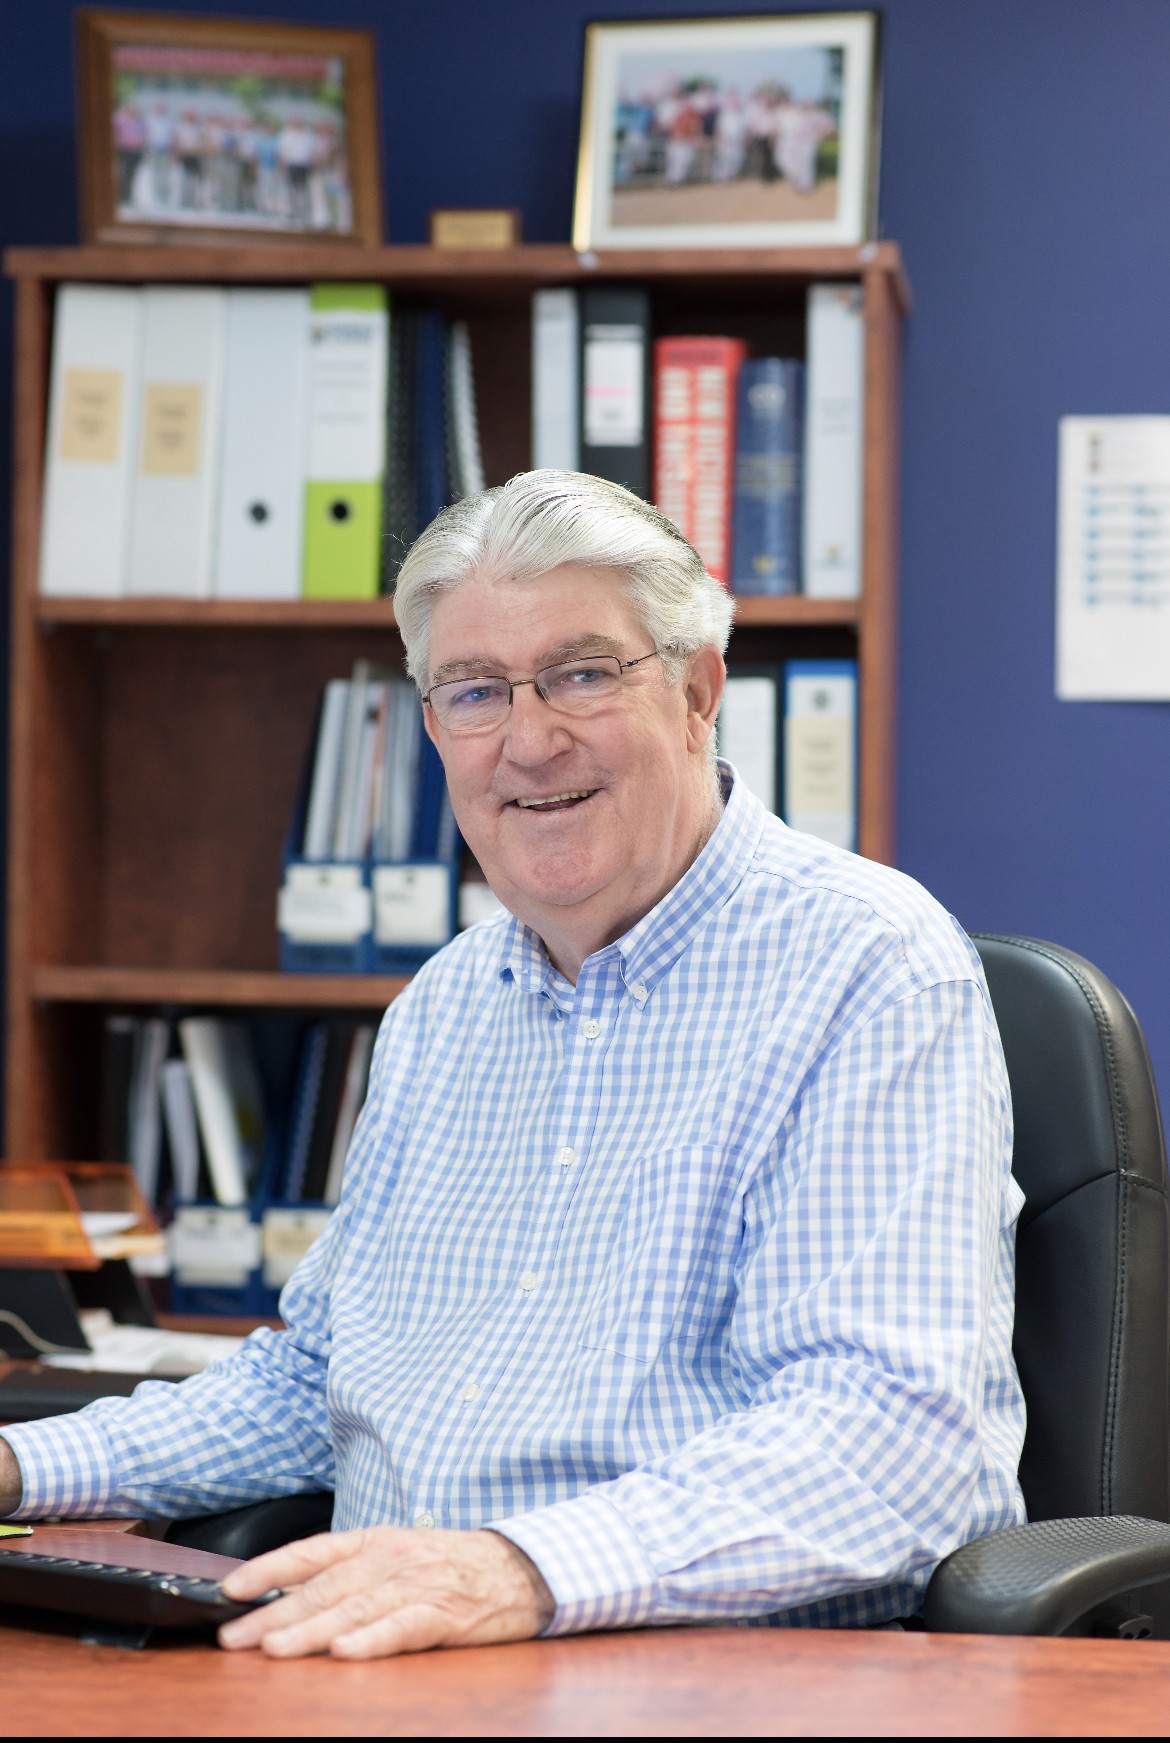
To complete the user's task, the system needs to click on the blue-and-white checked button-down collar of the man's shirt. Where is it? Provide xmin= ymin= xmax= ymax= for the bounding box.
xmin=499 ymin=760 xmax=765 ymax=1002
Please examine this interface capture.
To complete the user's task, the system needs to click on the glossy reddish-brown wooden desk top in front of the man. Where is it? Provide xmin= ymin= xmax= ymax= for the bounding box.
xmin=0 ymin=1628 xmax=1170 ymax=1736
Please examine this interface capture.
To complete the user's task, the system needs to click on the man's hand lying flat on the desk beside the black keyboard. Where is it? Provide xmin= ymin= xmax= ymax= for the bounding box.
xmin=220 ymin=1525 xmax=556 ymax=1658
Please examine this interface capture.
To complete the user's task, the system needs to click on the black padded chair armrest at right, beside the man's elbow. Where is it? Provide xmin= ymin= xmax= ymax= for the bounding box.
xmin=922 ymin=1516 xmax=1170 ymax=1635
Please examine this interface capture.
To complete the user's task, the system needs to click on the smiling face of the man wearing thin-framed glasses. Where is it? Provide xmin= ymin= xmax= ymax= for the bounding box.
xmin=427 ymin=563 xmax=722 ymax=960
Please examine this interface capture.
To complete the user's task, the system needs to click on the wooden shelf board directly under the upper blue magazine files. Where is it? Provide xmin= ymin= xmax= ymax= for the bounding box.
xmin=31 ymin=967 xmax=410 ymax=1011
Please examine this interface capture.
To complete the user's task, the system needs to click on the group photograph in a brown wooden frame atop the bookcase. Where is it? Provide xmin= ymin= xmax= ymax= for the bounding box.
xmin=77 ymin=10 xmax=382 ymax=244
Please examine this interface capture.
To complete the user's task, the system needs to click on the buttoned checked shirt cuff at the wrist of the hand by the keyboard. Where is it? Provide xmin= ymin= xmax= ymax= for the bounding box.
xmin=490 ymin=1490 xmax=659 ymax=1638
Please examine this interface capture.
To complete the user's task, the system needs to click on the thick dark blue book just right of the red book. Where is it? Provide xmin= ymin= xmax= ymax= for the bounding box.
xmin=731 ymin=357 xmax=804 ymax=594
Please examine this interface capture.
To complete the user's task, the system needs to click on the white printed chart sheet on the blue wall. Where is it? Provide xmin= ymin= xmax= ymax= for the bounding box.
xmin=1057 ymin=417 xmax=1170 ymax=702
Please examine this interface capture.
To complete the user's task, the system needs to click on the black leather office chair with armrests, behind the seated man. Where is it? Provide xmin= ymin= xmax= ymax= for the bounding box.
xmin=167 ymin=934 xmax=1170 ymax=1638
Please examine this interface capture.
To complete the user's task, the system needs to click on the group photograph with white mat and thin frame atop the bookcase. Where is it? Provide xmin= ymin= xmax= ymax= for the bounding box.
xmin=574 ymin=12 xmax=879 ymax=251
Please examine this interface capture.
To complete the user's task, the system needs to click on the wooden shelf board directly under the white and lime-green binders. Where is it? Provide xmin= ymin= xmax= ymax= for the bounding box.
xmin=37 ymin=594 xmax=860 ymax=629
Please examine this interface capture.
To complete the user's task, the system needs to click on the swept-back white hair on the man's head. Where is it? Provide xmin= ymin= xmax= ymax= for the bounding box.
xmin=394 ymin=469 xmax=732 ymax=688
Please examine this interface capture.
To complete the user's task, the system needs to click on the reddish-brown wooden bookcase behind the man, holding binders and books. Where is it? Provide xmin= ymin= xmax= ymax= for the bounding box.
xmin=5 ymin=242 xmax=910 ymax=1159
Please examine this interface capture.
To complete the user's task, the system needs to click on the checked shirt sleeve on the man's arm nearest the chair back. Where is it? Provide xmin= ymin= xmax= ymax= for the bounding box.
xmin=492 ymin=981 xmax=1022 ymax=1633
